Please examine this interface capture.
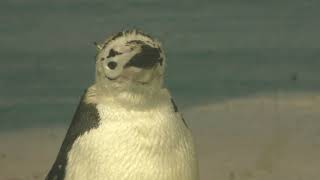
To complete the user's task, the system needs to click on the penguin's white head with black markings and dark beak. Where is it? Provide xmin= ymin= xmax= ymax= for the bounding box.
xmin=96 ymin=30 xmax=165 ymax=93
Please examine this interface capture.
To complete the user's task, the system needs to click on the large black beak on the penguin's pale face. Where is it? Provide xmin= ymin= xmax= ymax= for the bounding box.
xmin=124 ymin=44 xmax=163 ymax=69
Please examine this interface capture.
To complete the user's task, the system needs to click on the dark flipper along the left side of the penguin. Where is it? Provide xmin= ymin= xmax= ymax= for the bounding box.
xmin=46 ymin=90 xmax=100 ymax=180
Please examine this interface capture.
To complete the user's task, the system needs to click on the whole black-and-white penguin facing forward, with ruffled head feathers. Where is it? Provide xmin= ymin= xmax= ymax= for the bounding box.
xmin=46 ymin=30 xmax=199 ymax=180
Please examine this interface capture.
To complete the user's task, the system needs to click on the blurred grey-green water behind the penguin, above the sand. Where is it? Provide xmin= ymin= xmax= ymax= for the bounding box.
xmin=0 ymin=0 xmax=320 ymax=129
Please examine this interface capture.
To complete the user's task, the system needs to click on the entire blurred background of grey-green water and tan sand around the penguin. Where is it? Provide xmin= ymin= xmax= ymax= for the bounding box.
xmin=0 ymin=0 xmax=320 ymax=180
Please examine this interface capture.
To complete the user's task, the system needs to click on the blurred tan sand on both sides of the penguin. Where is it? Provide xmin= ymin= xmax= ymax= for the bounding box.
xmin=0 ymin=94 xmax=320 ymax=180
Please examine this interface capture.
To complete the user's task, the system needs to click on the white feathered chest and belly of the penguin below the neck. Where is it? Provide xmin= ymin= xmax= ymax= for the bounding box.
xmin=66 ymin=104 xmax=198 ymax=180
